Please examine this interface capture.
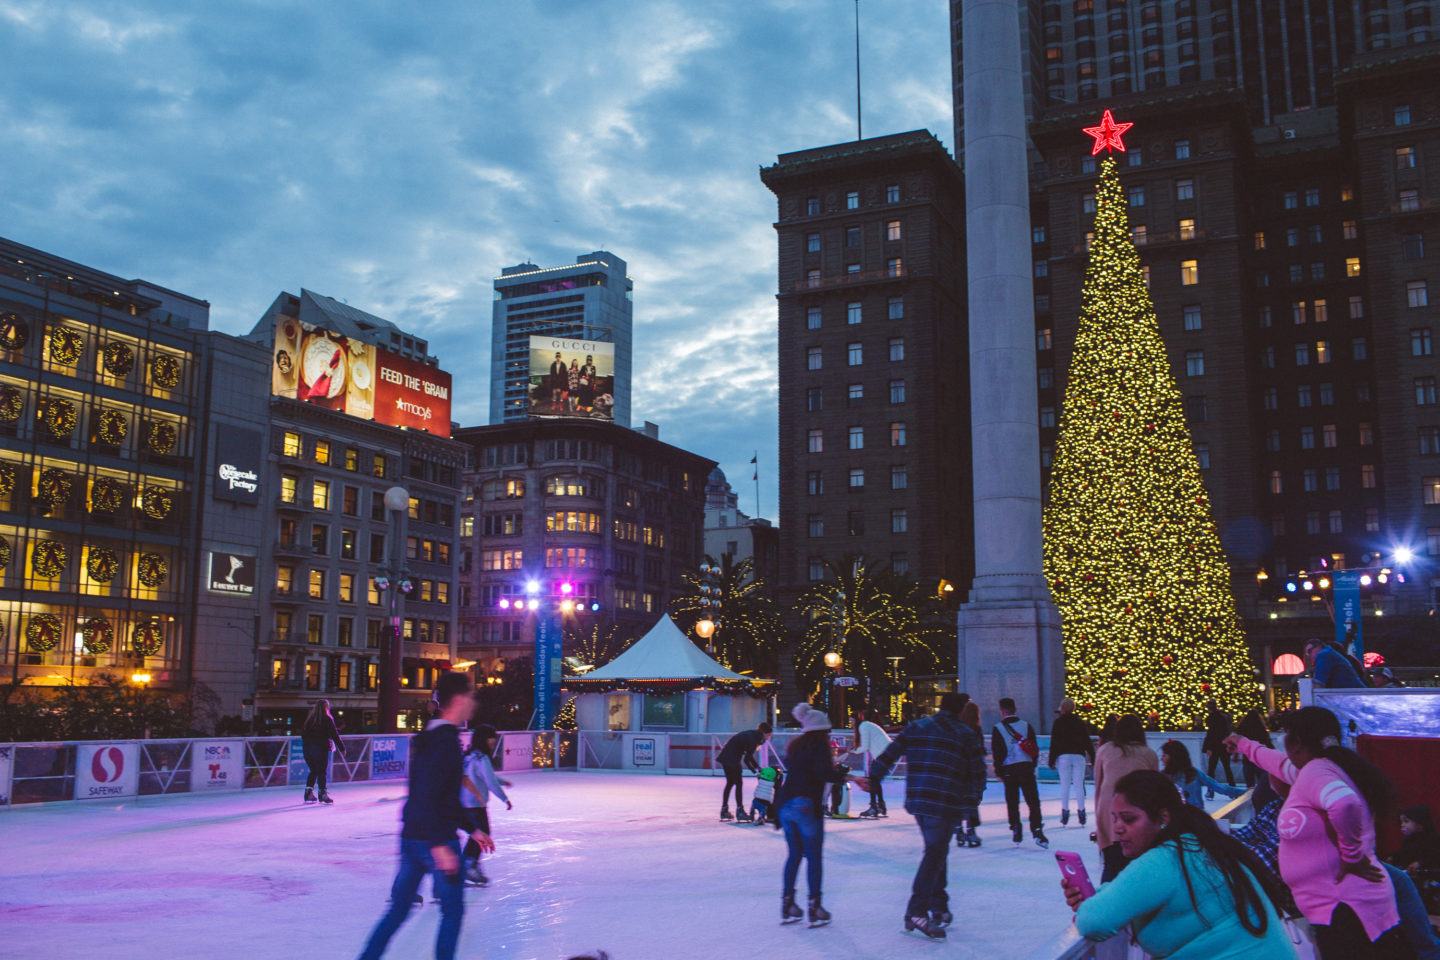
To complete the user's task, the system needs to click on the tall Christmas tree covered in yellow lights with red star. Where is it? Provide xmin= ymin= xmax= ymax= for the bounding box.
xmin=1044 ymin=111 xmax=1259 ymax=728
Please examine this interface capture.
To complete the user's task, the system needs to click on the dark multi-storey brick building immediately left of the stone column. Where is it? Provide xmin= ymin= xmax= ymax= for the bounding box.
xmin=760 ymin=131 xmax=973 ymax=601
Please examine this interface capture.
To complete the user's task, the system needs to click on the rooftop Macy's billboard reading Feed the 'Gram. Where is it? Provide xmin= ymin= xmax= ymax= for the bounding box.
xmin=271 ymin=315 xmax=451 ymax=436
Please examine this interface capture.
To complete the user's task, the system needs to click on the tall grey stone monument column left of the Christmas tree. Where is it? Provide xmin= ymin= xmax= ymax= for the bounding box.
xmin=959 ymin=0 xmax=1064 ymax=730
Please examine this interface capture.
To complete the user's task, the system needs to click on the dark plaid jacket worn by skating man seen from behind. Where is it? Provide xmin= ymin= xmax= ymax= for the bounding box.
xmin=870 ymin=712 xmax=985 ymax=820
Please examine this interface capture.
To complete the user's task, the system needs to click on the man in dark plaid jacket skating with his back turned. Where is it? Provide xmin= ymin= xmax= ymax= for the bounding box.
xmin=861 ymin=692 xmax=985 ymax=940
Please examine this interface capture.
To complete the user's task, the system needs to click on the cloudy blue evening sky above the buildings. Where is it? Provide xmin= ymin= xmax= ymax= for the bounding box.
xmin=0 ymin=0 xmax=952 ymax=526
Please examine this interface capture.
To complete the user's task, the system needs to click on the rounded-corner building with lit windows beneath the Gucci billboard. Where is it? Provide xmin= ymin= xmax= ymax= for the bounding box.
xmin=455 ymin=419 xmax=716 ymax=672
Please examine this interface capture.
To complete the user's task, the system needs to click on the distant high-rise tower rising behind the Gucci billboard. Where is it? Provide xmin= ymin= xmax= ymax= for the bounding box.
xmin=490 ymin=250 xmax=635 ymax=426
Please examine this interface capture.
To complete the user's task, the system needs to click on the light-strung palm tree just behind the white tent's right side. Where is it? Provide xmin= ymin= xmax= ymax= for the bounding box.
xmin=670 ymin=556 xmax=785 ymax=671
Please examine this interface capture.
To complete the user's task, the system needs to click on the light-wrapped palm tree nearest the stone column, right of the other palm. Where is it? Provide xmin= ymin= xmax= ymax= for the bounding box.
xmin=799 ymin=556 xmax=946 ymax=678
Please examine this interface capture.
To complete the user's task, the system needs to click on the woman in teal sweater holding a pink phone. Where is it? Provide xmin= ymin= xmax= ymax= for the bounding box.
xmin=1061 ymin=770 xmax=1296 ymax=960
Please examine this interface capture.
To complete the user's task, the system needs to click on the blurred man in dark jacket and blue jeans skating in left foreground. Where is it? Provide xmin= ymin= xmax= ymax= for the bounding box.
xmin=360 ymin=674 xmax=495 ymax=960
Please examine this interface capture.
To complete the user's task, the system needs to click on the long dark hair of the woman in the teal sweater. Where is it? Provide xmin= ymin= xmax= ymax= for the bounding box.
xmin=1115 ymin=770 xmax=1295 ymax=937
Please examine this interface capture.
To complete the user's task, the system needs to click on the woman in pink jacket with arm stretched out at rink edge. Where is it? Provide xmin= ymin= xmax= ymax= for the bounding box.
xmin=1225 ymin=707 xmax=1410 ymax=960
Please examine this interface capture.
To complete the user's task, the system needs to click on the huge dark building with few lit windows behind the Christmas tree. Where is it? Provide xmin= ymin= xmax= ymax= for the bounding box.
xmin=952 ymin=0 xmax=1440 ymax=662
